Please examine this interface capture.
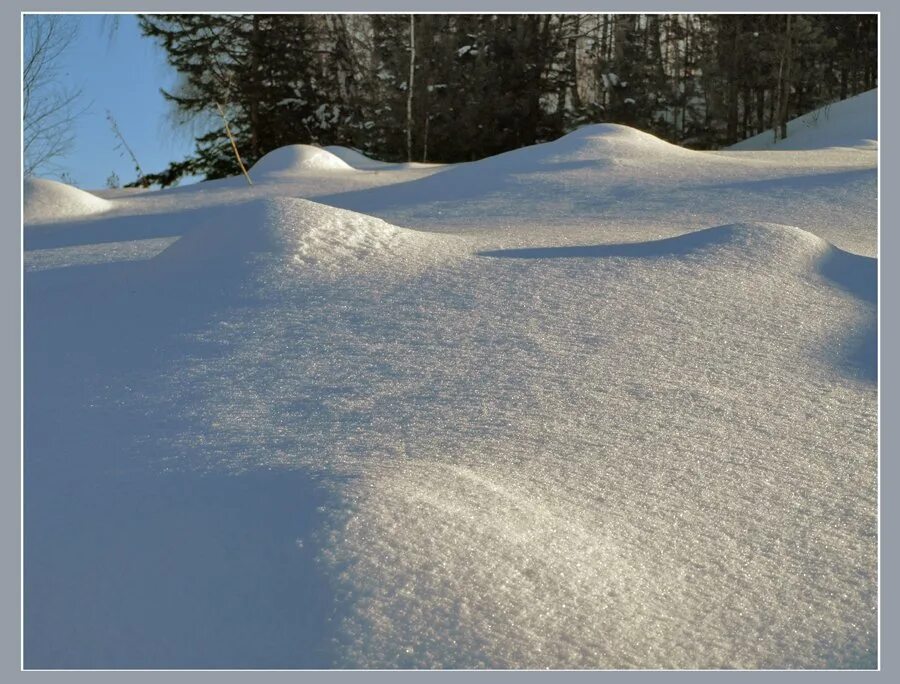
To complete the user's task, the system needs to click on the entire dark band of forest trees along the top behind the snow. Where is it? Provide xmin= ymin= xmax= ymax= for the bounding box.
xmin=139 ymin=14 xmax=878 ymax=186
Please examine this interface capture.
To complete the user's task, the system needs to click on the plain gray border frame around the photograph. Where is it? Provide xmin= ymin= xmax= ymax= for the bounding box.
xmin=0 ymin=0 xmax=900 ymax=682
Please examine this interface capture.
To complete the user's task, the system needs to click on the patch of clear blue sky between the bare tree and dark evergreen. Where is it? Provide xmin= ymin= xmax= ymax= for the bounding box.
xmin=46 ymin=15 xmax=199 ymax=189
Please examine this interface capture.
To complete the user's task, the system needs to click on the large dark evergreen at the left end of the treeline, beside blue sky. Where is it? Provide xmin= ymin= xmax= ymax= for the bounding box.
xmin=139 ymin=14 xmax=355 ymax=184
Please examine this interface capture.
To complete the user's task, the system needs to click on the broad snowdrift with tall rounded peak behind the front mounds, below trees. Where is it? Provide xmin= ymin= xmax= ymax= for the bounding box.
xmin=320 ymin=124 xmax=877 ymax=256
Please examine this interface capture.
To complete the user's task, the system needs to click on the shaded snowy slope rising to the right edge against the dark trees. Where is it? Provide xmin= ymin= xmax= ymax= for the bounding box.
xmin=730 ymin=89 xmax=878 ymax=150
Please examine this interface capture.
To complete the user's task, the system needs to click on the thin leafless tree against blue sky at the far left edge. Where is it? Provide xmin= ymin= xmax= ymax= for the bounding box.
xmin=22 ymin=14 xmax=81 ymax=176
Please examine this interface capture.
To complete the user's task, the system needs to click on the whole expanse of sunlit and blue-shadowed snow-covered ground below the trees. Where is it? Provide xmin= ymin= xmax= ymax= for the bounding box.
xmin=24 ymin=93 xmax=877 ymax=668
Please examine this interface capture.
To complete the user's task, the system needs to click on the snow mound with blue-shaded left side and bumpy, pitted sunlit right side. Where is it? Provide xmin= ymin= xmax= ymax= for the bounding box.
xmin=156 ymin=197 xmax=458 ymax=273
